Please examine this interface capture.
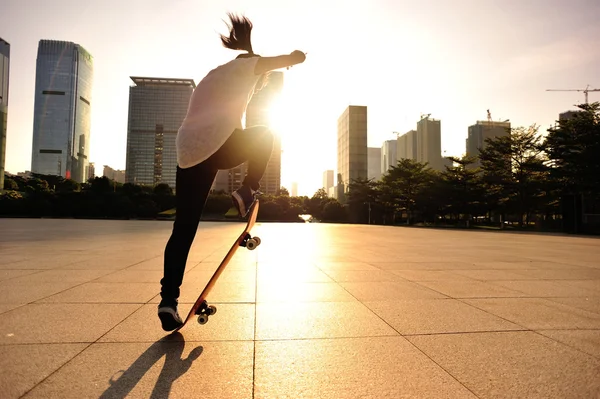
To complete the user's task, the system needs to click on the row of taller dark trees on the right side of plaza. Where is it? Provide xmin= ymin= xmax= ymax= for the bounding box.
xmin=346 ymin=103 xmax=600 ymax=232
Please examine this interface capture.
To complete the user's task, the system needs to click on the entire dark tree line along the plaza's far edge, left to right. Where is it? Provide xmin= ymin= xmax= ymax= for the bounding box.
xmin=0 ymin=103 xmax=600 ymax=232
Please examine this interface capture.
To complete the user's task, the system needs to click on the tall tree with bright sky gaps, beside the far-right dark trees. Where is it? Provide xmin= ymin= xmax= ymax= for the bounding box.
xmin=479 ymin=125 xmax=548 ymax=227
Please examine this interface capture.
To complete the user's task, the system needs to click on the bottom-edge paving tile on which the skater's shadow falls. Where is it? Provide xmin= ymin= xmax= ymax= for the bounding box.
xmin=25 ymin=338 xmax=254 ymax=399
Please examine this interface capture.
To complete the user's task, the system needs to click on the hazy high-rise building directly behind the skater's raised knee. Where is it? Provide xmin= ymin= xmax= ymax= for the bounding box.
xmin=212 ymin=72 xmax=283 ymax=195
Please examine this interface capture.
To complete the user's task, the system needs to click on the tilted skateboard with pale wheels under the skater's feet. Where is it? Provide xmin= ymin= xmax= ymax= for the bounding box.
xmin=173 ymin=199 xmax=260 ymax=333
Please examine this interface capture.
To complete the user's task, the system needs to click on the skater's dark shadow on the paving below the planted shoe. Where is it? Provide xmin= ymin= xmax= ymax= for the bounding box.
xmin=100 ymin=333 xmax=203 ymax=399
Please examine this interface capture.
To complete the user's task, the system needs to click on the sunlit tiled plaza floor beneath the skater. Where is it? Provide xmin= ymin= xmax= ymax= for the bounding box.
xmin=0 ymin=219 xmax=600 ymax=399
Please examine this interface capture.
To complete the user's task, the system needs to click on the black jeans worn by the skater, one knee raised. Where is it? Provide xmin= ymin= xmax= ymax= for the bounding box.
xmin=160 ymin=126 xmax=273 ymax=305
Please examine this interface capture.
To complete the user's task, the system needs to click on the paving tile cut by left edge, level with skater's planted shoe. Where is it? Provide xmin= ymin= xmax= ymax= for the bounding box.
xmin=0 ymin=304 xmax=140 ymax=345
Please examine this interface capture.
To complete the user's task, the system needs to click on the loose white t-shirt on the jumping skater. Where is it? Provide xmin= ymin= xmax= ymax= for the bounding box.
xmin=176 ymin=57 xmax=260 ymax=169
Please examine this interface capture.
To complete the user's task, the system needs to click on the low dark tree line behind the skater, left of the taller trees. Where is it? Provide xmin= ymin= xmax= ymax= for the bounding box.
xmin=0 ymin=173 xmax=347 ymax=222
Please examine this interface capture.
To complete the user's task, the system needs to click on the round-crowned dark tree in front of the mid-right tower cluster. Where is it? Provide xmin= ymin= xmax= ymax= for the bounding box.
xmin=382 ymin=159 xmax=435 ymax=224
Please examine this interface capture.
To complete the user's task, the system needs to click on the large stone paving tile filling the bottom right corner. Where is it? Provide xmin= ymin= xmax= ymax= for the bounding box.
xmin=407 ymin=331 xmax=600 ymax=399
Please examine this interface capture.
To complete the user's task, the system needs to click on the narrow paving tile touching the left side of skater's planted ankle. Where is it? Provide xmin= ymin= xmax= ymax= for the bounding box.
xmin=40 ymin=282 xmax=160 ymax=303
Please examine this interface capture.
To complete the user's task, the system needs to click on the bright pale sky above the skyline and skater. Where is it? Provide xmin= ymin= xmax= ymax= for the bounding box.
xmin=0 ymin=0 xmax=600 ymax=195
